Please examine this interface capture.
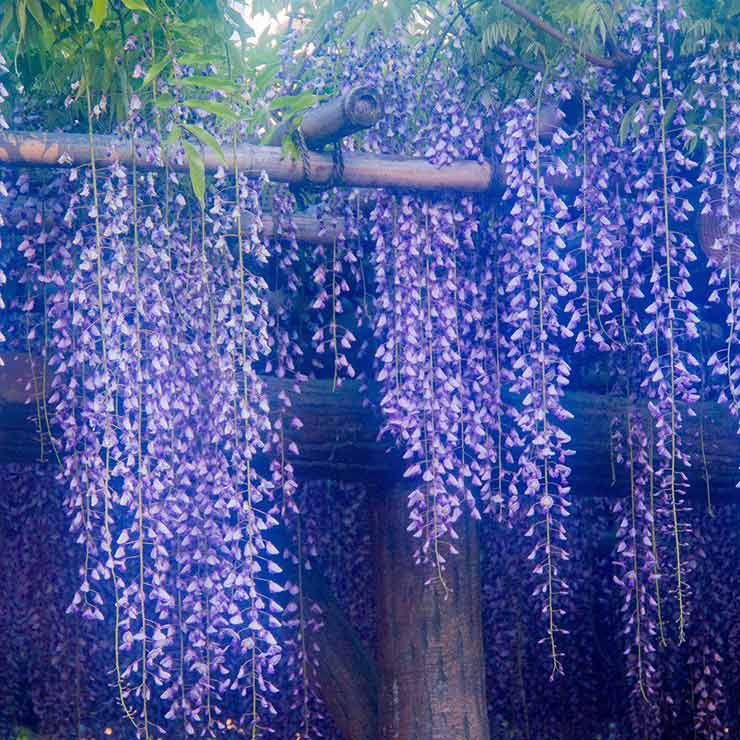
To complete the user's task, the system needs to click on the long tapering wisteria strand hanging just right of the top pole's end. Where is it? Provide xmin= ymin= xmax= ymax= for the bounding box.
xmin=500 ymin=80 xmax=578 ymax=675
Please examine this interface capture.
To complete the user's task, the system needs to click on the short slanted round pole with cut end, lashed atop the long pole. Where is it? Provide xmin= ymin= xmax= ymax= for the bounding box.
xmin=268 ymin=85 xmax=383 ymax=149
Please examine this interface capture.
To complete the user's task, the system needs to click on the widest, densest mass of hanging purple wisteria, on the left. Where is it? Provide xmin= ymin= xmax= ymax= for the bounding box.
xmin=7 ymin=88 xmax=290 ymax=736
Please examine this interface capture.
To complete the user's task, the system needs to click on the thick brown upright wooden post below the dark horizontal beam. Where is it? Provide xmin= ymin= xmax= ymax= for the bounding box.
xmin=374 ymin=487 xmax=490 ymax=740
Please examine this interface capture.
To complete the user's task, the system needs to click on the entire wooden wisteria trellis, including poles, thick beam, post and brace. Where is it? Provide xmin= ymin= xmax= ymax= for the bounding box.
xmin=0 ymin=88 xmax=735 ymax=740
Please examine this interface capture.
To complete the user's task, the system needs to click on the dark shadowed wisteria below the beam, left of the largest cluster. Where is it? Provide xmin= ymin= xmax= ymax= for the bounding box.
xmin=0 ymin=465 xmax=120 ymax=738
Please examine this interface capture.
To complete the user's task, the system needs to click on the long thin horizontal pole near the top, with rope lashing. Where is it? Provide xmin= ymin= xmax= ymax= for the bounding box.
xmin=0 ymin=131 xmax=492 ymax=192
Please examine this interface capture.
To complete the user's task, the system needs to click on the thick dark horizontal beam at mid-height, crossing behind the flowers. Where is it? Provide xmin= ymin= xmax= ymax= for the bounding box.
xmin=0 ymin=353 xmax=740 ymax=500
